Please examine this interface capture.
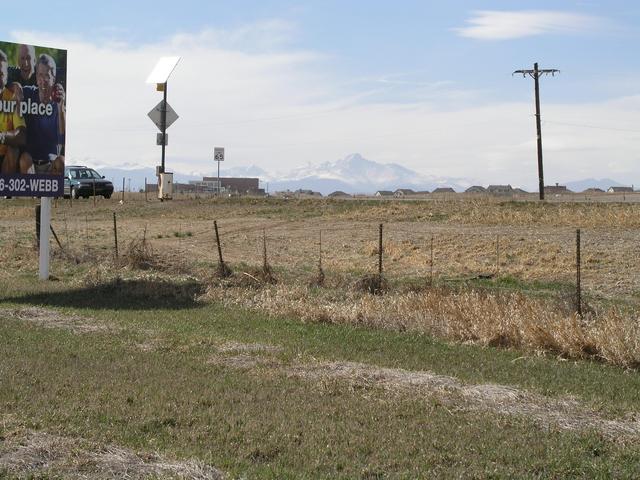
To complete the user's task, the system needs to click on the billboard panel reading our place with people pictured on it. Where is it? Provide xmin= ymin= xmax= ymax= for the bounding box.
xmin=0 ymin=42 xmax=67 ymax=197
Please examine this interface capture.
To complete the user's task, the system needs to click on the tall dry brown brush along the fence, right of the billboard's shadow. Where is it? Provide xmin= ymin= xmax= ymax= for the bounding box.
xmin=205 ymin=285 xmax=640 ymax=368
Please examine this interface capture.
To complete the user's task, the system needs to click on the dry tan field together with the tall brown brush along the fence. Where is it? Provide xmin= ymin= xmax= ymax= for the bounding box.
xmin=0 ymin=195 xmax=640 ymax=366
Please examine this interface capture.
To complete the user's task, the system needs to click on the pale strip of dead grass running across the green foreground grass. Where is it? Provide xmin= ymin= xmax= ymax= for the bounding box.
xmin=6 ymin=307 xmax=640 ymax=442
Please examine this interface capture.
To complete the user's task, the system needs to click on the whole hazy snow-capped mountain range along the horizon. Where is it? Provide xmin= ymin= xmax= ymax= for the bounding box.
xmin=90 ymin=153 xmax=622 ymax=195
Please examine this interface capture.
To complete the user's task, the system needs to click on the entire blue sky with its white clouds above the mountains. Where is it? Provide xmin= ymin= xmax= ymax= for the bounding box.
xmin=3 ymin=0 xmax=640 ymax=186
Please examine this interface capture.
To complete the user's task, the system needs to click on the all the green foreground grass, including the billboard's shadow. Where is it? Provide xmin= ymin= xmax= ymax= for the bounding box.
xmin=0 ymin=272 xmax=640 ymax=478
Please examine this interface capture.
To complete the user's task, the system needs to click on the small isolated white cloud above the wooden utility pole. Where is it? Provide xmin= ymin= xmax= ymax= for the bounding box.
xmin=454 ymin=10 xmax=606 ymax=40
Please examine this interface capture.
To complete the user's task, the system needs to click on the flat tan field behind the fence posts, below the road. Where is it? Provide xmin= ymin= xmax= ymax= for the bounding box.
xmin=0 ymin=201 xmax=640 ymax=303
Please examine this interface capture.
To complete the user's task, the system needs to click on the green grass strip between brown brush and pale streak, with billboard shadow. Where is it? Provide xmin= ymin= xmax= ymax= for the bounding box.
xmin=0 ymin=279 xmax=640 ymax=413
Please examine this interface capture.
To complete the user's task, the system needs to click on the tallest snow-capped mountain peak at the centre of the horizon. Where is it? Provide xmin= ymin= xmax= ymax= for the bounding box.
xmin=269 ymin=153 xmax=471 ymax=195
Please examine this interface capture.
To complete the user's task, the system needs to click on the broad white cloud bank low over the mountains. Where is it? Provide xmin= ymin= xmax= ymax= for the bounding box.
xmin=6 ymin=25 xmax=640 ymax=186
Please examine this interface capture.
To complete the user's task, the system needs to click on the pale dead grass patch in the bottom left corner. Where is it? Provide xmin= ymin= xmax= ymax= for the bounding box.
xmin=0 ymin=431 xmax=223 ymax=480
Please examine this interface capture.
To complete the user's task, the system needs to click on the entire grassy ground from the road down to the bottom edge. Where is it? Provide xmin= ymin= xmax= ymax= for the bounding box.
xmin=0 ymin=195 xmax=640 ymax=478
